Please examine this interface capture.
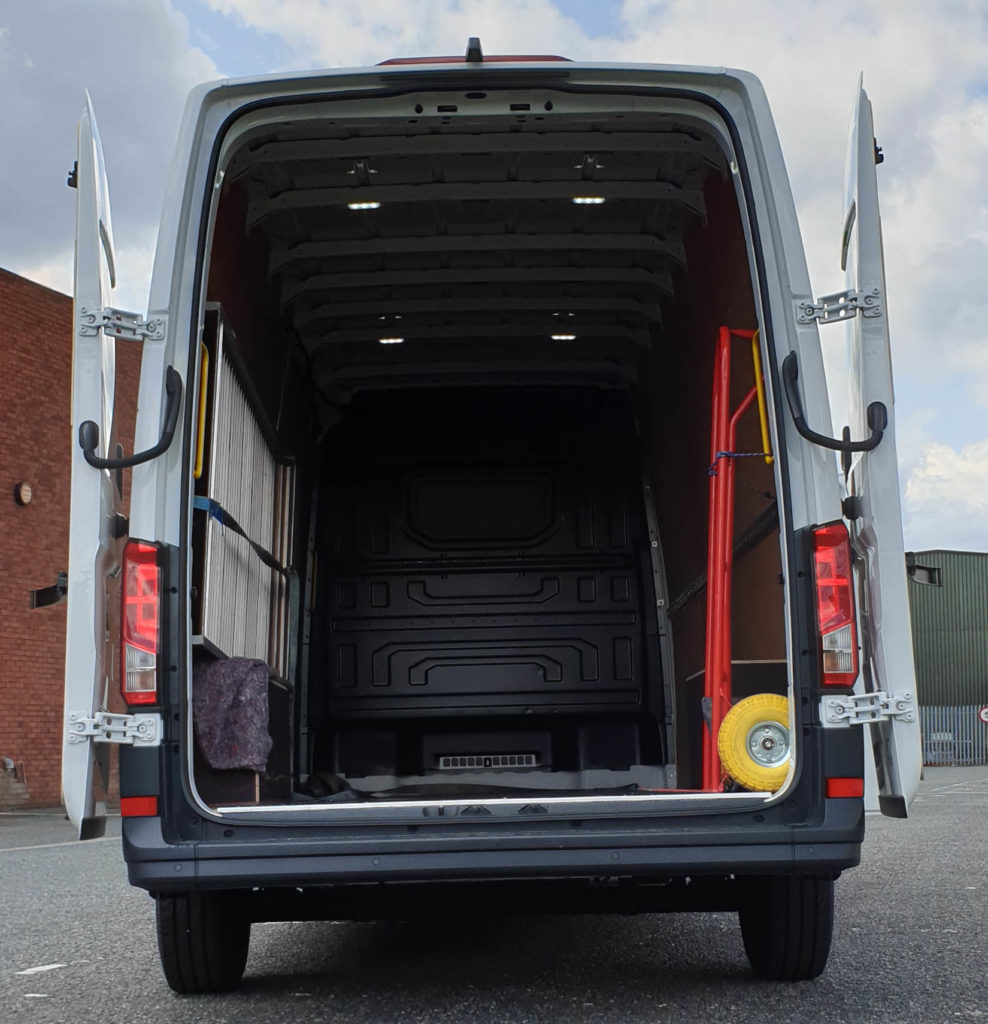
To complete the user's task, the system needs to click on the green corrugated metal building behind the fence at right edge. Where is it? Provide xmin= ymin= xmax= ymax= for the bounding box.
xmin=906 ymin=550 xmax=988 ymax=764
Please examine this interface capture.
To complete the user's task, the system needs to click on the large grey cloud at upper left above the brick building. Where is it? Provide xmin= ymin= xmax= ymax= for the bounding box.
xmin=0 ymin=0 xmax=216 ymax=308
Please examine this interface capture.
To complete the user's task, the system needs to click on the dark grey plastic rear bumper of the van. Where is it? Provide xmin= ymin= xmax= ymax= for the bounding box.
xmin=123 ymin=800 xmax=864 ymax=892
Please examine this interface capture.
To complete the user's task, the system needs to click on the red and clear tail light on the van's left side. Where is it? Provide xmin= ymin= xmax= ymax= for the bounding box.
xmin=120 ymin=541 xmax=161 ymax=705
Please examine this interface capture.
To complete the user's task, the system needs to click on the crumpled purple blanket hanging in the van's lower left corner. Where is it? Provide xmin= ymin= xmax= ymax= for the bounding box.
xmin=192 ymin=657 xmax=271 ymax=771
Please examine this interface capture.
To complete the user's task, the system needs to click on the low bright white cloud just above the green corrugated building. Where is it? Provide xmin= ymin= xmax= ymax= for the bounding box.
xmin=903 ymin=439 xmax=988 ymax=551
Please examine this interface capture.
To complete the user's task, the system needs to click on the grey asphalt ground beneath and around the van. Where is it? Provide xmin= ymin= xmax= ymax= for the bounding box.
xmin=0 ymin=767 xmax=988 ymax=1024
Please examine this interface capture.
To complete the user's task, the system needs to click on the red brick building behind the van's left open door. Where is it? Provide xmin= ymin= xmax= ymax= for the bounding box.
xmin=0 ymin=270 xmax=140 ymax=810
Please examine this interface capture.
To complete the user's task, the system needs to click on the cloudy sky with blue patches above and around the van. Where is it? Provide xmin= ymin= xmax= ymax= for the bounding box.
xmin=0 ymin=0 xmax=988 ymax=550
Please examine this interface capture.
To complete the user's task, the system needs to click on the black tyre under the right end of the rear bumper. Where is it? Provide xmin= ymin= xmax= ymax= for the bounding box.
xmin=738 ymin=876 xmax=833 ymax=981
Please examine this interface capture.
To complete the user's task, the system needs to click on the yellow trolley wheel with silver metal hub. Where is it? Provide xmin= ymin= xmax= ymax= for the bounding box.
xmin=717 ymin=693 xmax=790 ymax=792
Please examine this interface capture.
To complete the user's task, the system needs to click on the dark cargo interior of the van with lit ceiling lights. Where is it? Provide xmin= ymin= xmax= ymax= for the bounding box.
xmin=188 ymin=96 xmax=790 ymax=813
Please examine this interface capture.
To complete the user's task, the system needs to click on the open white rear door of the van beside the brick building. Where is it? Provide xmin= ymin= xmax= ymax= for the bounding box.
xmin=61 ymin=93 xmax=122 ymax=839
